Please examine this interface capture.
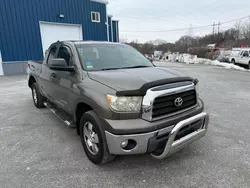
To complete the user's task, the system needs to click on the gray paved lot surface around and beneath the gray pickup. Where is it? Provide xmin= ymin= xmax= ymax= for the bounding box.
xmin=0 ymin=63 xmax=250 ymax=188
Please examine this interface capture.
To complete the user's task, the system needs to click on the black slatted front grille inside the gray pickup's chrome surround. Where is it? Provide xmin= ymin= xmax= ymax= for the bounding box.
xmin=152 ymin=90 xmax=197 ymax=119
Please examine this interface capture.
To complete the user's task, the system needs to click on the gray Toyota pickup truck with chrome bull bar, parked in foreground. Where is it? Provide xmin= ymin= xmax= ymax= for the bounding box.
xmin=28 ymin=41 xmax=209 ymax=164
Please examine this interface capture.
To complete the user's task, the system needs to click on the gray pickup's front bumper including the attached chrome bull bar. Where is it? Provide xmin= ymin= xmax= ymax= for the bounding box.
xmin=105 ymin=112 xmax=209 ymax=159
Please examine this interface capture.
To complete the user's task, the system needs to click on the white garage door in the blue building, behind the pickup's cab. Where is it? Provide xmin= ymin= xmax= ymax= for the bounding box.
xmin=40 ymin=22 xmax=82 ymax=53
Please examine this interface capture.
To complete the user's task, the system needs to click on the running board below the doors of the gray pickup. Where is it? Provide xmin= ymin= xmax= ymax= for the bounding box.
xmin=43 ymin=101 xmax=76 ymax=129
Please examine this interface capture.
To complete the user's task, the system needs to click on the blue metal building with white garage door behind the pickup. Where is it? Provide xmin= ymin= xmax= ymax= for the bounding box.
xmin=0 ymin=0 xmax=119 ymax=75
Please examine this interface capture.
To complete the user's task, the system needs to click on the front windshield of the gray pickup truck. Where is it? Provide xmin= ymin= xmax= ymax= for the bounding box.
xmin=76 ymin=43 xmax=153 ymax=71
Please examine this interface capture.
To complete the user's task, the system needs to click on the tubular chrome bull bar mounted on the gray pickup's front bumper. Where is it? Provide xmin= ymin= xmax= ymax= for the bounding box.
xmin=151 ymin=112 xmax=209 ymax=159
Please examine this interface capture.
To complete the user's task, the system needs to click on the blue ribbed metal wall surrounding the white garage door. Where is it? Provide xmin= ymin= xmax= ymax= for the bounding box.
xmin=0 ymin=0 xmax=107 ymax=62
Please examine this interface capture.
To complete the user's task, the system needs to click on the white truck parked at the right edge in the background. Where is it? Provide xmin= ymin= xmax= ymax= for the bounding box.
xmin=229 ymin=48 xmax=250 ymax=69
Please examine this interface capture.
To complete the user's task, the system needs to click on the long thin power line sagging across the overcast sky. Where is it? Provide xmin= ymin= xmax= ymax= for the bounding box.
xmin=120 ymin=15 xmax=249 ymax=33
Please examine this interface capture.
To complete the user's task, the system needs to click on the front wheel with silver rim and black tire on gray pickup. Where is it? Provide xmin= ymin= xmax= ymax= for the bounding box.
xmin=80 ymin=111 xmax=115 ymax=165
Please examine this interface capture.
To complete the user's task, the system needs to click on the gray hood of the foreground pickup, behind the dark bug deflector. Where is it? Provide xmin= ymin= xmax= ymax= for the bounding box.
xmin=88 ymin=67 xmax=186 ymax=91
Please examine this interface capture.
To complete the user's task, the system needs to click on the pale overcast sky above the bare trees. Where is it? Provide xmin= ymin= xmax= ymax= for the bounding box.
xmin=108 ymin=0 xmax=250 ymax=42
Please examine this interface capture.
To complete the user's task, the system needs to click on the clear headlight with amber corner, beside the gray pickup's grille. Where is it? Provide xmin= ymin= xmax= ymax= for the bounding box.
xmin=107 ymin=95 xmax=142 ymax=112
